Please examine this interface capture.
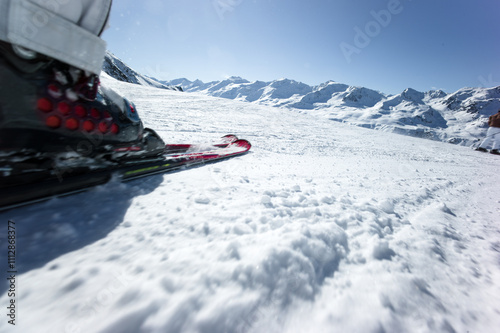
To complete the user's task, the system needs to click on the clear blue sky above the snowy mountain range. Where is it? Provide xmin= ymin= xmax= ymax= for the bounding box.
xmin=103 ymin=0 xmax=500 ymax=94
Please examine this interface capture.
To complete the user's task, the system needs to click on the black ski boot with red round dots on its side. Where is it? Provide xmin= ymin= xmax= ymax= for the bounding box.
xmin=0 ymin=42 xmax=165 ymax=165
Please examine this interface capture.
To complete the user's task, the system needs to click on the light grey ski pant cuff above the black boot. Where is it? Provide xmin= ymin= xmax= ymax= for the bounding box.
xmin=0 ymin=0 xmax=112 ymax=74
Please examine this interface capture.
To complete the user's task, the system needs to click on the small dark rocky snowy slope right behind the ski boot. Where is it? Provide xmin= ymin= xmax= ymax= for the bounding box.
xmin=102 ymin=51 xmax=180 ymax=90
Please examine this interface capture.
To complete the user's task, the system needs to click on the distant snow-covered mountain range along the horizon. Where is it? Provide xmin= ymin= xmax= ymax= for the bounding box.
xmin=164 ymin=77 xmax=500 ymax=146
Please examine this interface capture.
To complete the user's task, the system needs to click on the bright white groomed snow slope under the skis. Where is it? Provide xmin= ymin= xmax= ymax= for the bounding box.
xmin=0 ymin=76 xmax=500 ymax=333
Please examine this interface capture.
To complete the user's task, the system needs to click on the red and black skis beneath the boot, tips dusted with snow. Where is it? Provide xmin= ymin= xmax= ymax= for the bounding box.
xmin=0 ymin=135 xmax=251 ymax=211
